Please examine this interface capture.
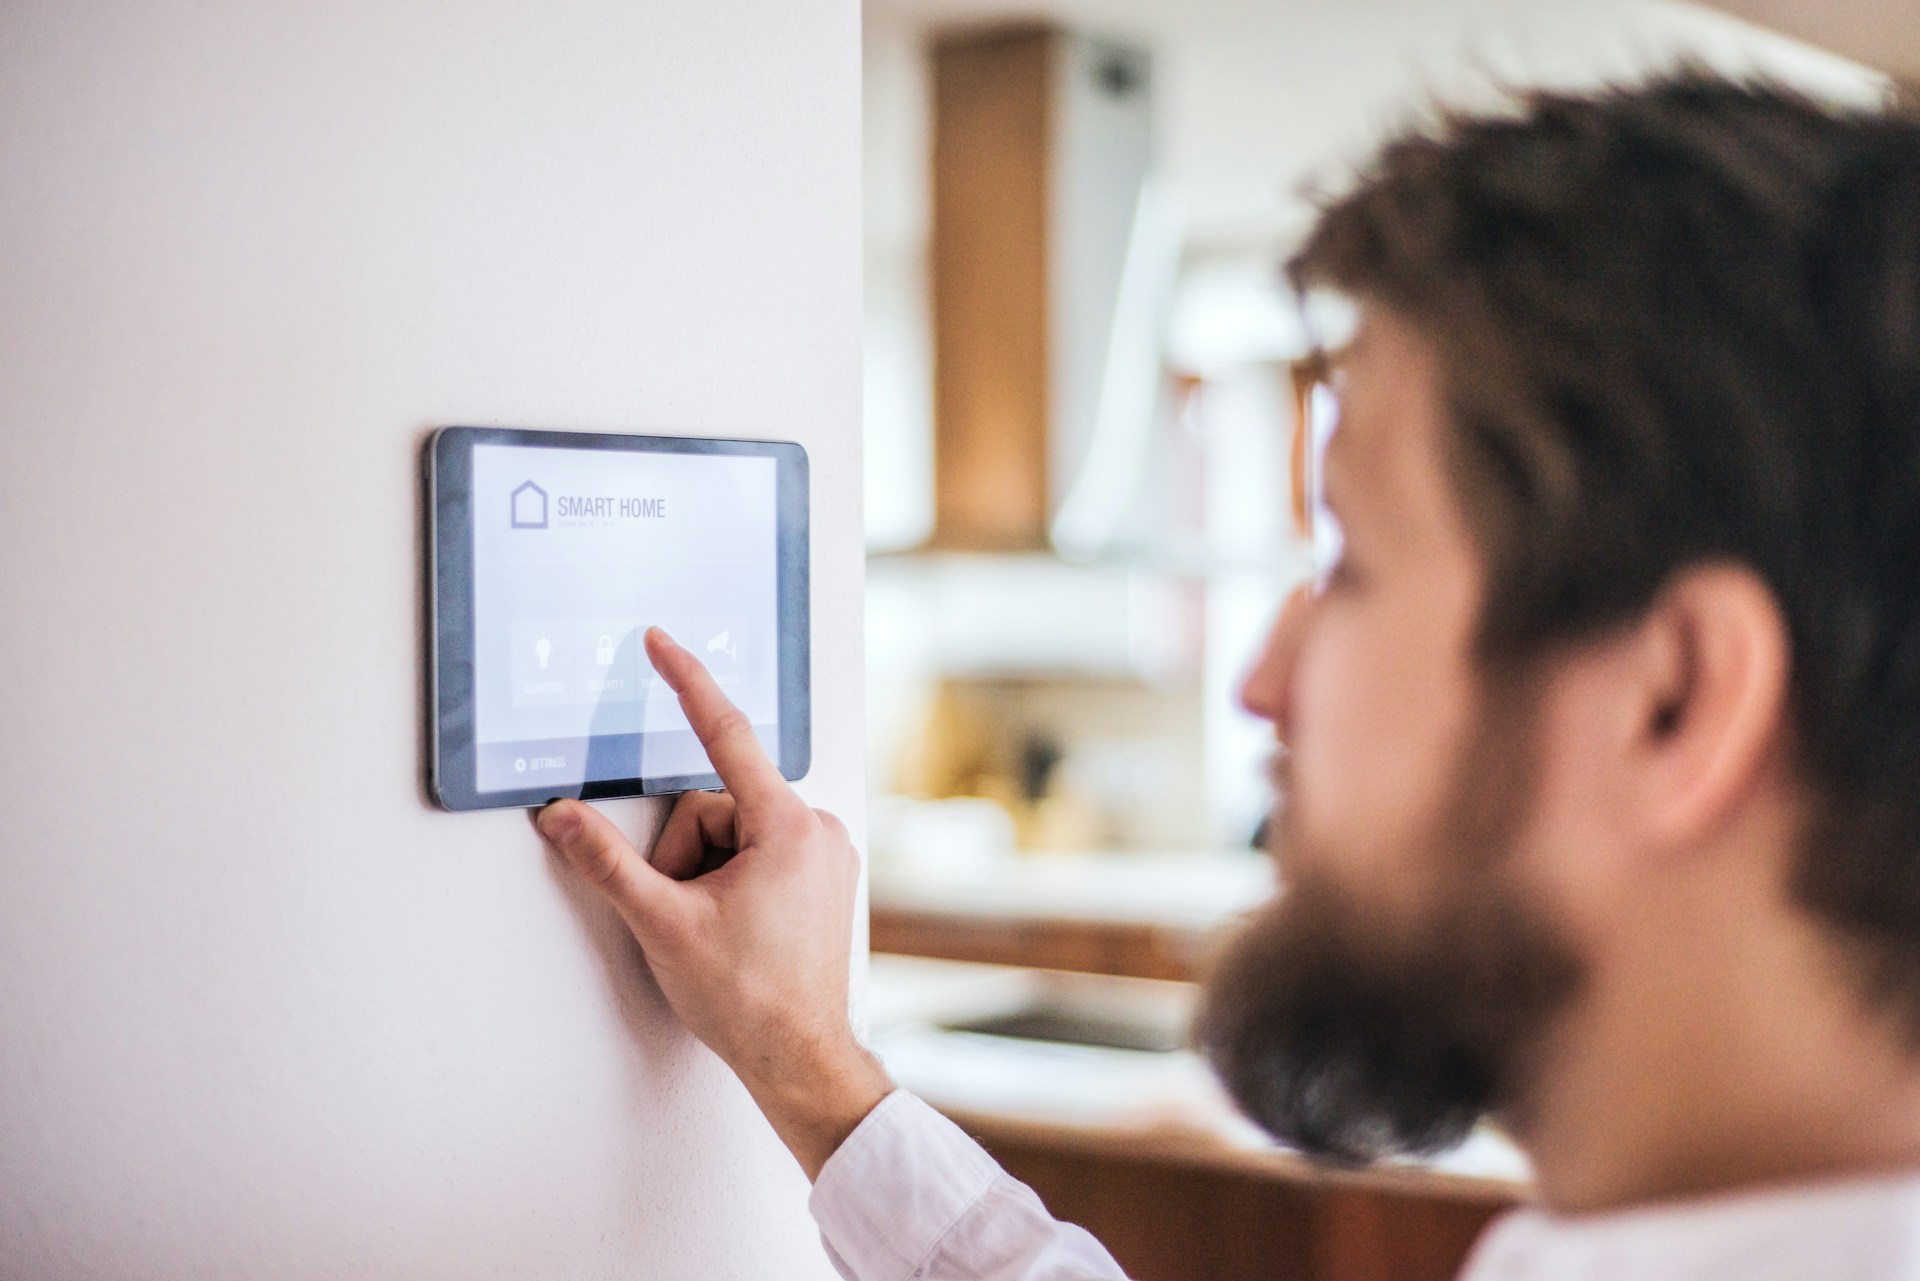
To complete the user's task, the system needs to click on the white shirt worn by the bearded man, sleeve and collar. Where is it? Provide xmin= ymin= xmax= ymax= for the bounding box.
xmin=808 ymin=1091 xmax=1920 ymax=1281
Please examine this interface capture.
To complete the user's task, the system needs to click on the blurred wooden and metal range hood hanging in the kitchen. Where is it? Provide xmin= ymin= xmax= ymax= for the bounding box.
xmin=931 ymin=25 xmax=1150 ymax=551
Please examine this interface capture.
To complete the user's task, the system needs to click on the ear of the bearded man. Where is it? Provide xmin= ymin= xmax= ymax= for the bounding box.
xmin=1628 ymin=565 xmax=1791 ymax=847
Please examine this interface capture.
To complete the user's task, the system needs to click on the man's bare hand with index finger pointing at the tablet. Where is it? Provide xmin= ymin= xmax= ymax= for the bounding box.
xmin=538 ymin=628 xmax=893 ymax=1179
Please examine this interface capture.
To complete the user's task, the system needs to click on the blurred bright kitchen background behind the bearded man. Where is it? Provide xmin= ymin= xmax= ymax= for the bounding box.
xmin=862 ymin=0 xmax=1920 ymax=1281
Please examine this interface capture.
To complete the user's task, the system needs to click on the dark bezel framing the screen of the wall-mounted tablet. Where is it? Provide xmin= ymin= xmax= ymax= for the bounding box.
xmin=426 ymin=426 xmax=812 ymax=810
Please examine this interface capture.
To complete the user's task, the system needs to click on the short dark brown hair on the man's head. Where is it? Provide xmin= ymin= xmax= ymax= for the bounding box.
xmin=1288 ymin=69 xmax=1920 ymax=1041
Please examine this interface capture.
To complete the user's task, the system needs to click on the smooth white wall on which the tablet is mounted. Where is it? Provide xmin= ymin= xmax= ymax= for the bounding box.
xmin=0 ymin=0 xmax=862 ymax=1279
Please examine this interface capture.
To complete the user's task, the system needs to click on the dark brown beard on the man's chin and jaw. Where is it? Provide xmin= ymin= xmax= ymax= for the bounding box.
xmin=1194 ymin=695 xmax=1580 ymax=1162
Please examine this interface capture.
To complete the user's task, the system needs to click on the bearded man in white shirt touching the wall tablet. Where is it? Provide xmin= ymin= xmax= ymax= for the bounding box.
xmin=540 ymin=73 xmax=1920 ymax=1281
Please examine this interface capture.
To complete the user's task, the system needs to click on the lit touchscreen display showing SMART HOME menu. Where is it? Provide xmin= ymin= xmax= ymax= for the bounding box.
xmin=472 ymin=444 xmax=781 ymax=793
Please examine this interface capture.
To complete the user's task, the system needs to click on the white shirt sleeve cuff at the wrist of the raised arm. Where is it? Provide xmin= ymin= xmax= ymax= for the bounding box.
xmin=806 ymin=1089 xmax=1125 ymax=1281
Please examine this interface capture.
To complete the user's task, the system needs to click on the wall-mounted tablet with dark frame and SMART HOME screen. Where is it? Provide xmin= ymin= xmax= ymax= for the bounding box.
xmin=426 ymin=426 xmax=812 ymax=810
